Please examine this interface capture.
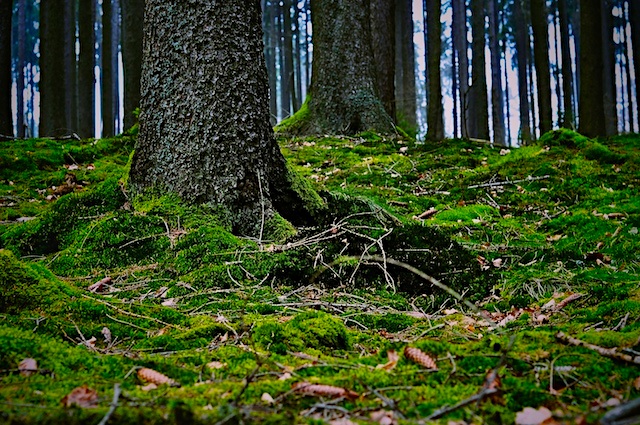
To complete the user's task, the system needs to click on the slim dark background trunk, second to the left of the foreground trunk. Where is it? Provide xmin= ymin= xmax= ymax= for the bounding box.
xmin=100 ymin=0 xmax=115 ymax=137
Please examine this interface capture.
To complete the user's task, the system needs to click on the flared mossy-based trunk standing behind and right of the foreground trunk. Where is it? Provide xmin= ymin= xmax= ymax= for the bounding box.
xmin=281 ymin=0 xmax=394 ymax=134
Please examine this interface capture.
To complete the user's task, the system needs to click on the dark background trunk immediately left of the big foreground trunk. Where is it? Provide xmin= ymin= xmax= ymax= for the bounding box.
xmin=121 ymin=0 xmax=145 ymax=130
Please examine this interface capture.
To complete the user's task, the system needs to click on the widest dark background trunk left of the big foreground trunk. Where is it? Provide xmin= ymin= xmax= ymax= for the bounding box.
xmin=39 ymin=0 xmax=67 ymax=137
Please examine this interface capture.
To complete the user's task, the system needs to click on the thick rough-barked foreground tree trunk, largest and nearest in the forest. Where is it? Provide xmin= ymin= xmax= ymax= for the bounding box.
xmin=129 ymin=0 xmax=322 ymax=237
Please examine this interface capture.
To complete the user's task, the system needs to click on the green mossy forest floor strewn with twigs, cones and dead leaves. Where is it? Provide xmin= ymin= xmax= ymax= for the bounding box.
xmin=0 ymin=131 xmax=640 ymax=425
